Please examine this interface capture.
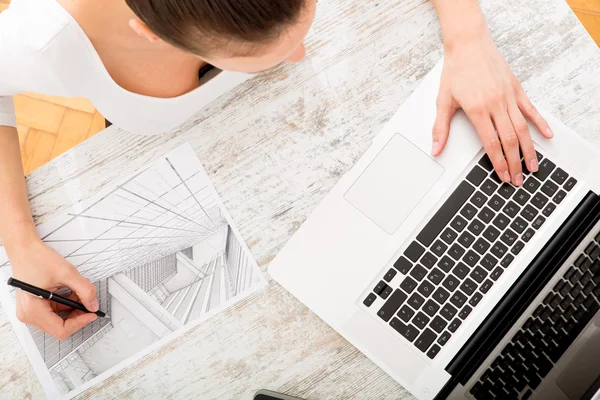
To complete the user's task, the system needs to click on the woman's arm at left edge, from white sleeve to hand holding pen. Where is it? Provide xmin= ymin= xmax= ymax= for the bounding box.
xmin=0 ymin=9 xmax=98 ymax=339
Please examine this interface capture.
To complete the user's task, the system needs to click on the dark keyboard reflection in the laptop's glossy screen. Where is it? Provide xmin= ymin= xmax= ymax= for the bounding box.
xmin=470 ymin=234 xmax=600 ymax=400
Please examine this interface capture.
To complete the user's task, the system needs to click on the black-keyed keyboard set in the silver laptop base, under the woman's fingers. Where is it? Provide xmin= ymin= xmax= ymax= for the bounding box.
xmin=363 ymin=152 xmax=577 ymax=359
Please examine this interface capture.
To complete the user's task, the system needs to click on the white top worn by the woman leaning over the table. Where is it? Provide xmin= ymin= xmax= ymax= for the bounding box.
xmin=0 ymin=0 xmax=250 ymax=135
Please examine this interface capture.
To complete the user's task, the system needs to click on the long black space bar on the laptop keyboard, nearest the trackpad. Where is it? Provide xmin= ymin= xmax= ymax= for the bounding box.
xmin=417 ymin=181 xmax=475 ymax=246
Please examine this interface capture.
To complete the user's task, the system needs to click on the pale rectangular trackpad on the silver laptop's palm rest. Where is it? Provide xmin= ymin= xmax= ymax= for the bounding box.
xmin=345 ymin=134 xmax=444 ymax=235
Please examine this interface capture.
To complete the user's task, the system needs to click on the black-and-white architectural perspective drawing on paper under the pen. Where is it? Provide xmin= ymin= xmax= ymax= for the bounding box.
xmin=0 ymin=145 xmax=264 ymax=397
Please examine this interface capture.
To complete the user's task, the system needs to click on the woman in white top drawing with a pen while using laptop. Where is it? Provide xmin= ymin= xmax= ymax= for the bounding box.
xmin=0 ymin=0 xmax=552 ymax=339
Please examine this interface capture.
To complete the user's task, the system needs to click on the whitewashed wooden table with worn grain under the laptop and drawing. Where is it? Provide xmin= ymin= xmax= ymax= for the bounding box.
xmin=0 ymin=0 xmax=600 ymax=399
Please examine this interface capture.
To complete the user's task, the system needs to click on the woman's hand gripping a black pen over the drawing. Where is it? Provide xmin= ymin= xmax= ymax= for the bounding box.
xmin=7 ymin=237 xmax=98 ymax=340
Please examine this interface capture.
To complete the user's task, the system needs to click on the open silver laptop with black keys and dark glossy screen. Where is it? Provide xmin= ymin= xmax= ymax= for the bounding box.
xmin=269 ymin=62 xmax=600 ymax=400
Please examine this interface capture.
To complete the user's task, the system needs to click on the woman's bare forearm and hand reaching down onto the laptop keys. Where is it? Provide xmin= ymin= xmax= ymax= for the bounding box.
xmin=431 ymin=0 xmax=553 ymax=186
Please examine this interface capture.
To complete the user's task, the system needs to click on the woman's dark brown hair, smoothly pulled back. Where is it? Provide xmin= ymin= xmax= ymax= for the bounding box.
xmin=126 ymin=0 xmax=306 ymax=55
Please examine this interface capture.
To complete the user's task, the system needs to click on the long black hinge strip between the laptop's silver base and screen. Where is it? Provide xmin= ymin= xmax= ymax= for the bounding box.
xmin=435 ymin=192 xmax=600 ymax=400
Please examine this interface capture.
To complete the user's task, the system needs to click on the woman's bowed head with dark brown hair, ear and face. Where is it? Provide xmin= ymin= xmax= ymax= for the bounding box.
xmin=126 ymin=0 xmax=316 ymax=72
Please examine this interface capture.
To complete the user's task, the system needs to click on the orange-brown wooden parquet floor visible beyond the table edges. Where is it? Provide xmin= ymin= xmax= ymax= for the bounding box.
xmin=0 ymin=0 xmax=600 ymax=174
